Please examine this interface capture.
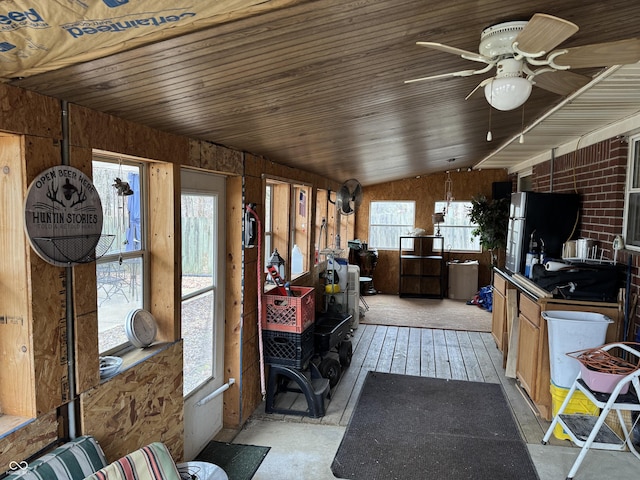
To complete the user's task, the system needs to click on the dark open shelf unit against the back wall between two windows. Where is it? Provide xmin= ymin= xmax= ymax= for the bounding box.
xmin=398 ymin=236 xmax=446 ymax=298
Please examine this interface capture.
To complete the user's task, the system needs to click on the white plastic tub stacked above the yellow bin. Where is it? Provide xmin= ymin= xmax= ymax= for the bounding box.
xmin=542 ymin=310 xmax=613 ymax=388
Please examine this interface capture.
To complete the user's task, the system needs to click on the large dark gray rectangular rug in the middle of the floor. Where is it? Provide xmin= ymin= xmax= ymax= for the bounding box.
xmin=331 ymin=372 xmax=538 ymax=480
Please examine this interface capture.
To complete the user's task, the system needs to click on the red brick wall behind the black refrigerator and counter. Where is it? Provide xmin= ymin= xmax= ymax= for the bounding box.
xmin=532 ymin=137 xmax=640 ymax=341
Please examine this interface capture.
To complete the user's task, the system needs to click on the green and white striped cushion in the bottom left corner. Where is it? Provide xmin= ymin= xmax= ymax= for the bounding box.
xmin=5 ymin=435 xmax=107 ymax=480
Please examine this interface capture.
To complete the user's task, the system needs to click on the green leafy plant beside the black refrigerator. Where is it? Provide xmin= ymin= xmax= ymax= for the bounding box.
xmin=469 ymin=195 xmax=510 ymax=266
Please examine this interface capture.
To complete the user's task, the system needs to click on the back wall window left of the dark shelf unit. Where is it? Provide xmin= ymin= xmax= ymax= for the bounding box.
xmin=369 ymin=201 xmax=416 ymax=250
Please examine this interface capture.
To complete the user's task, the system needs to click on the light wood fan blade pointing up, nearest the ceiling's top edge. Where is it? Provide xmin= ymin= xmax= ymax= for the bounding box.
xmin=515 ymin=13 xmax=578 ymax=54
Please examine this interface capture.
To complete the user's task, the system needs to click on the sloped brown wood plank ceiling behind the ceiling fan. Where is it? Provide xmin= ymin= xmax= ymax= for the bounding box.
xmin=11 ymin=0 xmax=640 ymax=185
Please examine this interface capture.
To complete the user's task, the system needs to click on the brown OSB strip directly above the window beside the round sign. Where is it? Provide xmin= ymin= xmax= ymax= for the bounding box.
xmin=68 ymin=104 xmax=189 ymax=165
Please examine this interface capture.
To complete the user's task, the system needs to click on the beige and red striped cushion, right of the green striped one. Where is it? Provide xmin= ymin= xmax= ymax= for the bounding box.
xmin=87 ymin=442 xmax=181 ymax=480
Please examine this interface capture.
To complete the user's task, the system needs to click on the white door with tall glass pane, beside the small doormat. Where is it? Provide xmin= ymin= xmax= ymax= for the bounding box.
xmin=181 ymin=170 xmax=225 ymax=460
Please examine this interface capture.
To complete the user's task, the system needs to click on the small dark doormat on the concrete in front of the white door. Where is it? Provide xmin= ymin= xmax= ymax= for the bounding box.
xmin=196 ymin=441 xmax=271 ymax=480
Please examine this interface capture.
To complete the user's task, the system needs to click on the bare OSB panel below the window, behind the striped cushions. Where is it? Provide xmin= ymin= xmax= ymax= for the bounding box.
xmin=80 ymin=341 xmax=184 ymax=461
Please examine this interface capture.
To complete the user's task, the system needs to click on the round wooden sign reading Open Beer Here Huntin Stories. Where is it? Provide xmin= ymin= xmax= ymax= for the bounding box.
xmin=24 ymin=165 xmax=102 ymax=267
